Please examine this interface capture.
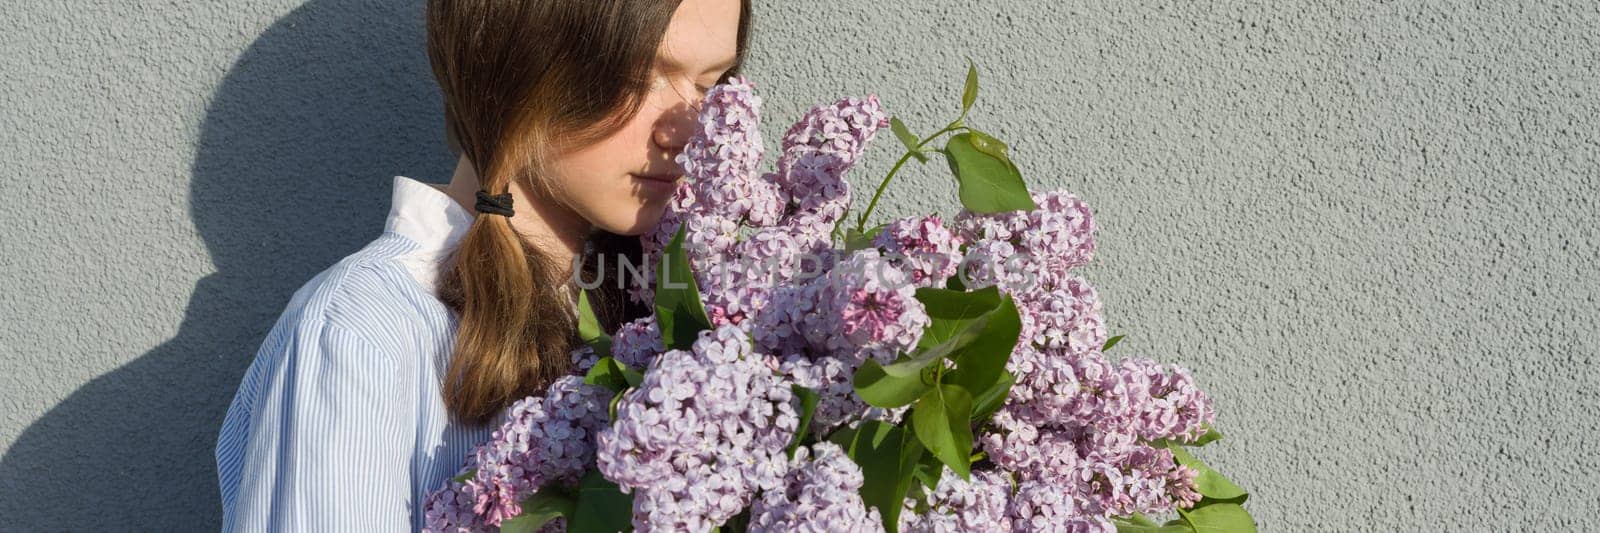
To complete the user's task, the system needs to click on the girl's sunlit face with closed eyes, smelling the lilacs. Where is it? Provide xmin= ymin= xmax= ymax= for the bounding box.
xmin=552 ymin=0 xmax=741 ymax=235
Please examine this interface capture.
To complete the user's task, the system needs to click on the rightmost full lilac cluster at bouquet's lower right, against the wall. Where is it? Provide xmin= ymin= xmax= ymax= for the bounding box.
xmin=978 ymin=349 xmax=1210 ymax=517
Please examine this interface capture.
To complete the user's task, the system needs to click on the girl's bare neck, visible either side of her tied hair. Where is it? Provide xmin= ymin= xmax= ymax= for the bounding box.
xmin=443 ymin=155 xmax=592 ymax=266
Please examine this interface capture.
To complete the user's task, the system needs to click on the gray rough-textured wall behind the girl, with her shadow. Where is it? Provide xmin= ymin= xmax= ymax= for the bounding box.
xmin=0 ymin=0 xmax=1600 ymax=531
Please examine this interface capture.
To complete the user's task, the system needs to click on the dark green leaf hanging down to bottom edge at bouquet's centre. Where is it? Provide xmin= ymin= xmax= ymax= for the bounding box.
xmin=845 ymin=419 xmax=923 ymax=533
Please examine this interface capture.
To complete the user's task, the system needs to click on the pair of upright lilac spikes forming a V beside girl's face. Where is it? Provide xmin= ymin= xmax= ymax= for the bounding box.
xmin=632 ymin=77 xmax=888 ymax=325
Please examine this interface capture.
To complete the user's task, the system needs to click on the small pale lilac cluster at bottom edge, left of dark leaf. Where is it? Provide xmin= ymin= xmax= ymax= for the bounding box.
xmin=750 ymin=442 xmax=883 ymax=533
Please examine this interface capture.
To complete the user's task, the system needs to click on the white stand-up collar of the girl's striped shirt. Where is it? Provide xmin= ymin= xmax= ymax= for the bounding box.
xmin=384 ymin=176 xmax=472 ymax=296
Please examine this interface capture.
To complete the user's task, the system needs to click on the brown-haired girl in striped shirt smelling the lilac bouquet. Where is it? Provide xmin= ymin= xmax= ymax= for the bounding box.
xmin=216 ymin=0 xmax=750 ymax=531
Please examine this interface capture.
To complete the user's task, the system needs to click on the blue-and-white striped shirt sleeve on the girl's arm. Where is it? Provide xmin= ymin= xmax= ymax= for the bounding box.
xmin=216 ymin=313 xmax=414 ymax=531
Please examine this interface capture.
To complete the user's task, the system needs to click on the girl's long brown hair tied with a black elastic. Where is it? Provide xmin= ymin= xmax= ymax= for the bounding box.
xmin=427 ymin=0 xmax=750 ymax=424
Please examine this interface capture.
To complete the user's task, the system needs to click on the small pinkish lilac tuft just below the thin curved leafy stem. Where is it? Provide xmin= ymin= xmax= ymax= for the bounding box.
xmin=872 ymin=214 xmax=962 ymax=287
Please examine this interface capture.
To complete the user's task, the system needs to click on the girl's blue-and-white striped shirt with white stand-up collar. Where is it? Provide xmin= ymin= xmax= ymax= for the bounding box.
xmin=216 ymin=176 xmax=493 ymax=531
